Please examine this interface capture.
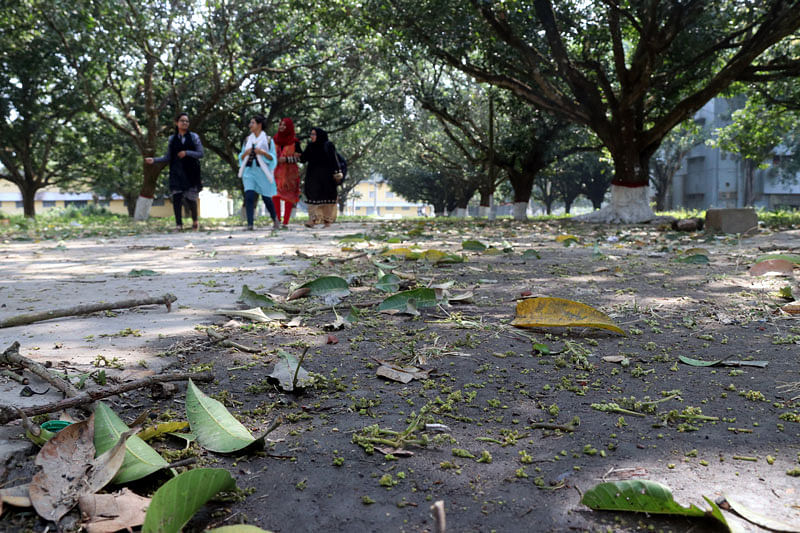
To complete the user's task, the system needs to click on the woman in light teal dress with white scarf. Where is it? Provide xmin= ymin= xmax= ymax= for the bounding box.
xmin=239 ymin=115 xmax=280 ymax=230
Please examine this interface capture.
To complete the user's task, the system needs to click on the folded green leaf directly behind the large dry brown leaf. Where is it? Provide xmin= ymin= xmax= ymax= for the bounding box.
xmin=94 ymin=402 xmax=169 ymax=484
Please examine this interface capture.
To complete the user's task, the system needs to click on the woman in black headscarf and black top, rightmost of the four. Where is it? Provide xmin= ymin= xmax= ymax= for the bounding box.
xmin=300 ymin=128 xmax=338 ymax=228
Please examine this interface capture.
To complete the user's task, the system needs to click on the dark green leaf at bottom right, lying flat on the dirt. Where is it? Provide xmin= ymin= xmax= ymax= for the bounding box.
xmin=581 ymin=480 xmax=706 ymax=516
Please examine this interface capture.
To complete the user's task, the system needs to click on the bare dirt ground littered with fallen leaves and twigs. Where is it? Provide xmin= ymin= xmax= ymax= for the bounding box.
xmin=0 ymin=221 xmax=800 ymax=532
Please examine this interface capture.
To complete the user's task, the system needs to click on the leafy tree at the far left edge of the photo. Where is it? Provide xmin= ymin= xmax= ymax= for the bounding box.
xmin=0 ymin=6 xmax=82 ymax=218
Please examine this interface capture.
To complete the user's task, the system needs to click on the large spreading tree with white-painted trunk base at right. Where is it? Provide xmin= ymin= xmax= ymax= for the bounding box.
xmin=364 ymin=0 xmax=800 ymax=222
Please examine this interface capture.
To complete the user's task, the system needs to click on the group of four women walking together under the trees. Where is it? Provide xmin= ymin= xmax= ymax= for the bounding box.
xmin=145 ymin=113 xmax=341 ymax=231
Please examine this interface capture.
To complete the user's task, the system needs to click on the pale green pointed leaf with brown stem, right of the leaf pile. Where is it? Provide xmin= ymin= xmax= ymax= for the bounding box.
xmin=186 ymin=380 xmax=256 ymax=453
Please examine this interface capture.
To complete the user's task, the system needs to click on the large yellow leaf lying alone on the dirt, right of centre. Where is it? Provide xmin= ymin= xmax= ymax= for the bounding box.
xmin=511 ymin=297 xmax=625 ymax=335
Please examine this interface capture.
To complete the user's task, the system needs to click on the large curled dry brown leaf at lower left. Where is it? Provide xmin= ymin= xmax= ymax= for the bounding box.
xmin=30 ymin=414 xmax=138 ymax=522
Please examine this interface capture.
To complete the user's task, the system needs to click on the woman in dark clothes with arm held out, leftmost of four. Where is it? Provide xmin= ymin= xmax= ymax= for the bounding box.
xmin=144 ymin=113 xmax=203 ymax=231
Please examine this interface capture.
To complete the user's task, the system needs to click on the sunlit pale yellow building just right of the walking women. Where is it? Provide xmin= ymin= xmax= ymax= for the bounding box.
xmin=344 ymin=180 xmax=433 ymax=218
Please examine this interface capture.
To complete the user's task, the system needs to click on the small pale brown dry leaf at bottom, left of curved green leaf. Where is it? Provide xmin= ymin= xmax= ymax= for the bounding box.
xmin=78 ymin=488 xmax=150 ymax=533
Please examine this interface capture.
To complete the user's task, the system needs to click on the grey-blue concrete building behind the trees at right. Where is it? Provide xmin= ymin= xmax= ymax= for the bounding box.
xmin=667 ymin=98 xmax=800 ymax=209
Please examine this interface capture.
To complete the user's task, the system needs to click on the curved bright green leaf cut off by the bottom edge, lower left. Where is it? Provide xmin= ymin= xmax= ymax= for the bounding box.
xmin=142 ymin=468 xmax=236 ymax=533
